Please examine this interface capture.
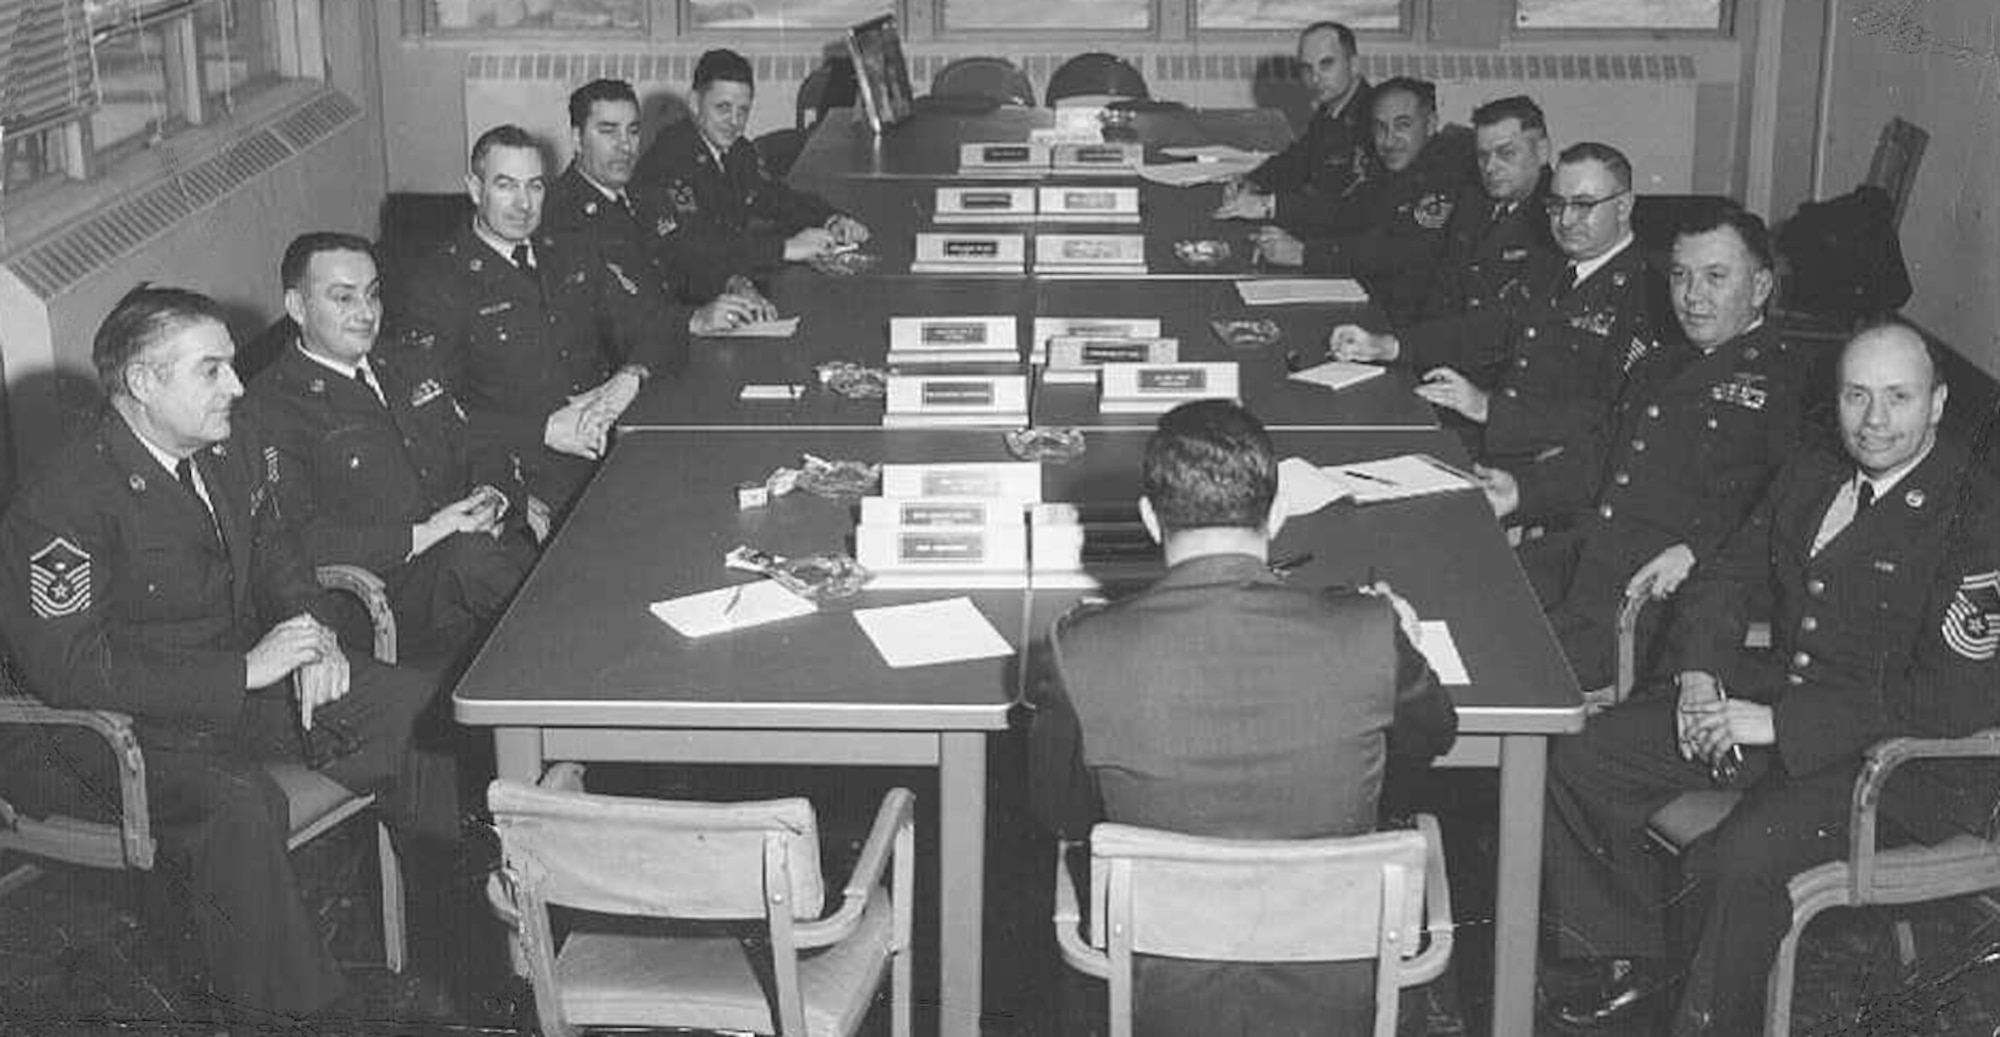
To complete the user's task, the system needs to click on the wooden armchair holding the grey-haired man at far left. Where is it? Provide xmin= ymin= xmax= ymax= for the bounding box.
xmin=0 ymin=565 xmax=408 ymax=973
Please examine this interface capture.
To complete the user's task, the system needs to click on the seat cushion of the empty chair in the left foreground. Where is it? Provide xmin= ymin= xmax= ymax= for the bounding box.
xmin=556 ymin=887 xmax=894 ymax=1037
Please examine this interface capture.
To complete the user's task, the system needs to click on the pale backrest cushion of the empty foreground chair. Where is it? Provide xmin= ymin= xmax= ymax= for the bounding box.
xmin=486 ymin=781 xmax=826 ymax=919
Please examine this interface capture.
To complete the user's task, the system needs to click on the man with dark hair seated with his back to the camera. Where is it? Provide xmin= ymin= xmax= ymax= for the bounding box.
xmin=1028 ymin=400 xmax=1458 ymax=1037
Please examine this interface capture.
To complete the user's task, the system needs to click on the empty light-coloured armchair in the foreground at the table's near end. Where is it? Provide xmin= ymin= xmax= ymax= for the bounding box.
xmin=486 ymin=781 xmax=914 ymax=1037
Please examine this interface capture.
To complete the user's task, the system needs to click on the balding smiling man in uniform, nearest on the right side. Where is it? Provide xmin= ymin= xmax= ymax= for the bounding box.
xmin=1544 ymin=324 xmax=2000 ymax=1035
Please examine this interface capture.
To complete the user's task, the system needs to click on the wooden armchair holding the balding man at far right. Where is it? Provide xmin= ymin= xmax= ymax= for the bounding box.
xmin=1618 ymin=599 xmax=2000 ymax=1037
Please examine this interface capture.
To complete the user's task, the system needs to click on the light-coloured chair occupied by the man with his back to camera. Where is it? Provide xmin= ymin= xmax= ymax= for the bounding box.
xmin=1054 ymin=815 xmax=1452 ymax=1037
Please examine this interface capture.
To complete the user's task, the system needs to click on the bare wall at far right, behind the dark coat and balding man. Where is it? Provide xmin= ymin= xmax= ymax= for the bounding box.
xmin=1820 ymin=0 xmax=2000 ymax=374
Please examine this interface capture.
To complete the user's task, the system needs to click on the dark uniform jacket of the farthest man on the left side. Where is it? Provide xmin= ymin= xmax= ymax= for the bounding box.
xmin=632 ymin=120 xmax=836 ymax=298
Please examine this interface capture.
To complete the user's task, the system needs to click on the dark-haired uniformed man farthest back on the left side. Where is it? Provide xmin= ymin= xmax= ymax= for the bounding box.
xmin=634 ymin=50 xmax=868 ymax=298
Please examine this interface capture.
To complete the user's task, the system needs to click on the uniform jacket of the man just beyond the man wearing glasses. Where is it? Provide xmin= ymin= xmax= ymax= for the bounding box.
xmin=1402 ymin=170 xmax=1564 ymax=336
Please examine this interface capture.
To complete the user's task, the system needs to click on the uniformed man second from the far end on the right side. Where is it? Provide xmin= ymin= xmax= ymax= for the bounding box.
xmin=1258 ymin=76 xmax=1474 ymax=326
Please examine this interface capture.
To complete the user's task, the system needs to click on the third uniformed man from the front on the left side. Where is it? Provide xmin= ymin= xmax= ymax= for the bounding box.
xmin=390 ymin=126 xmax=688 ymax=537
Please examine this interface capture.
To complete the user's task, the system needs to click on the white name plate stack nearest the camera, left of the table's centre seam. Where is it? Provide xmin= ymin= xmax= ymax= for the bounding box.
xmin=854 ymin=460 xmax=1042 ymax=591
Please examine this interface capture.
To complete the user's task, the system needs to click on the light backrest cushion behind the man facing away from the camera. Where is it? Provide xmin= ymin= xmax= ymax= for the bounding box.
xmin=1090 ymin=825 xmax=1426 ymax=961
